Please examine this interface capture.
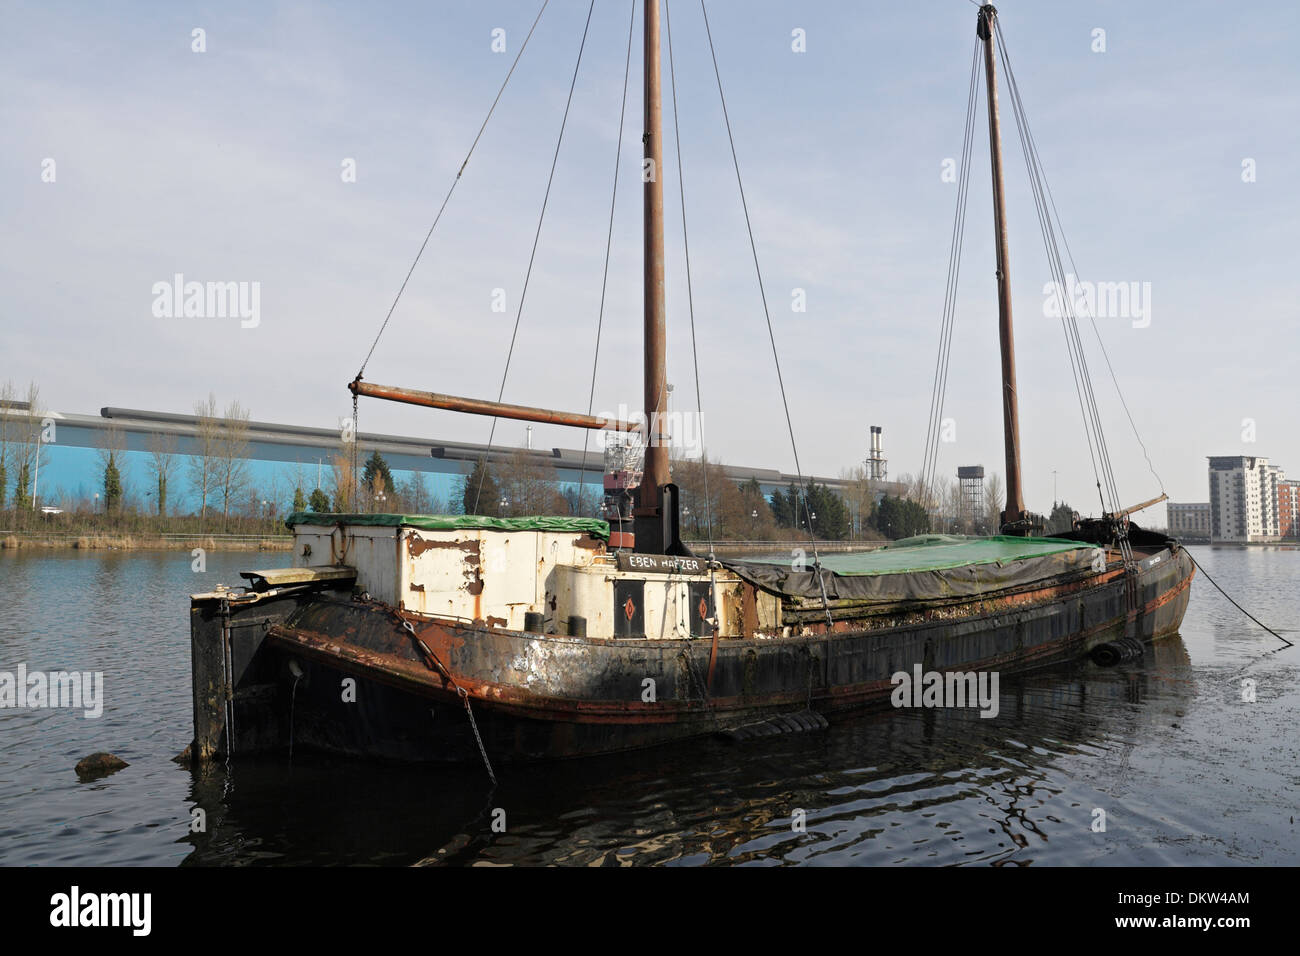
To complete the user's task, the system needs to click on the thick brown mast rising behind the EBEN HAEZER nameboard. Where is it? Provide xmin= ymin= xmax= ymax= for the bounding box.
xmin=633 ymin=0 xmax=668 ymax=551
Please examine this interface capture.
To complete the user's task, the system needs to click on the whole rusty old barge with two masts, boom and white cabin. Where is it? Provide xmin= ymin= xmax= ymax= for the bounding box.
xmin=191 ymin=3 xmax=1193 ymax=766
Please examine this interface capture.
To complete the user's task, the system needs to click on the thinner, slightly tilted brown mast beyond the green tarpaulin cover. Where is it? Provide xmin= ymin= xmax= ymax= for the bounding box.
xmin=975 ymin=4 xmax=1024 ymax=525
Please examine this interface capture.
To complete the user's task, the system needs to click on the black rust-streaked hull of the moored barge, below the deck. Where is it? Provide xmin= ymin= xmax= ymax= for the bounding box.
xmin=195 ymin=550 xmax=1193 ymax=761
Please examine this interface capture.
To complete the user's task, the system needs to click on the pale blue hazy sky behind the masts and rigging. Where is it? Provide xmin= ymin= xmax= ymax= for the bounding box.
xmin=0 ymin=0 xmax=1300 ymax=523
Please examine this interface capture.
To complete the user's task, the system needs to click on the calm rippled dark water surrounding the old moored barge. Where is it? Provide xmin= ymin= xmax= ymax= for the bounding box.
xmin=0 ymin=548 xmax=1300 ymax=866
